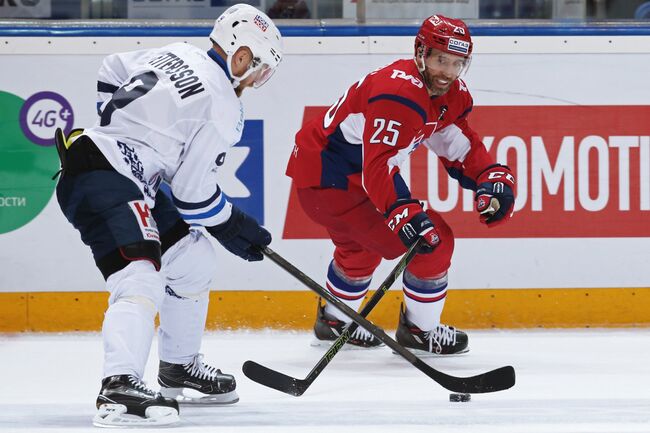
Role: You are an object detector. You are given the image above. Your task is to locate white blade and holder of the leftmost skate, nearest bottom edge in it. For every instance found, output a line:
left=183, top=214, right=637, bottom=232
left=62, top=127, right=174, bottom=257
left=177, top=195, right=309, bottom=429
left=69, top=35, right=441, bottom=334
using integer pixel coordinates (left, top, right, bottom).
left=93, top=404, right=180, bottom=428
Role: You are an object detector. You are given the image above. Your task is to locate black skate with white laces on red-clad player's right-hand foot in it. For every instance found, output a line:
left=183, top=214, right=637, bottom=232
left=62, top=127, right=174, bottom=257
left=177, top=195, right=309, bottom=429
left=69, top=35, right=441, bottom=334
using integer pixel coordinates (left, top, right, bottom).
left=395, top=306, right=469, bottom=356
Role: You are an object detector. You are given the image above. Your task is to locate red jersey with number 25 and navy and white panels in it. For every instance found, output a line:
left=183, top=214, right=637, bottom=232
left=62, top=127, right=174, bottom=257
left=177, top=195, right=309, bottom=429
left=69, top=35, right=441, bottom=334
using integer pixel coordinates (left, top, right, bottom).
left=287, top=59, right=494, bottom=213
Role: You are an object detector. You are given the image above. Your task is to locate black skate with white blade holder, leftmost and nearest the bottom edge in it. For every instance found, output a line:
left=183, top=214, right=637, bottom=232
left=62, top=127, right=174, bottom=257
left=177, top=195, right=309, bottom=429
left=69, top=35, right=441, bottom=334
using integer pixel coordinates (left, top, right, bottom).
left=93, top=374, right=179, bottom=427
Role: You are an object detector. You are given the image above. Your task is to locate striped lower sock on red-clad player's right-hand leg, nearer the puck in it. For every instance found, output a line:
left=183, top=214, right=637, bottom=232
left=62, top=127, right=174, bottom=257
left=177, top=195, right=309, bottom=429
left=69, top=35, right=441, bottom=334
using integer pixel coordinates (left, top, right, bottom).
left=402, top=270, right=447, bottom=331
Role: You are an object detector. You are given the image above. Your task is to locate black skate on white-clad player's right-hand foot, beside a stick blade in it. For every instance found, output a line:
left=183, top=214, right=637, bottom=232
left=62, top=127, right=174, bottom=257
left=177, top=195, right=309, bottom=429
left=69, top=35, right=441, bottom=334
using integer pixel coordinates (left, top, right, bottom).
left=158, top=353, right=239, bottom=405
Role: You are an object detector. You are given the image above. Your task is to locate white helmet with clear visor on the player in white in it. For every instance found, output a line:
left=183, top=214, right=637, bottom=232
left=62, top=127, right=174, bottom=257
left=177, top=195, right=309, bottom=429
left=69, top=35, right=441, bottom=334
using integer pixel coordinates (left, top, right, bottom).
left=210, top=3, right=282, bottom=88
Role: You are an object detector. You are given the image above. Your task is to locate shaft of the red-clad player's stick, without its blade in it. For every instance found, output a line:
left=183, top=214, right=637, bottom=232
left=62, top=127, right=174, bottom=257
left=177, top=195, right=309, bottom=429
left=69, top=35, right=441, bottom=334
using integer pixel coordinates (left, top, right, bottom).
left=302, top=238, right=423, bottom=386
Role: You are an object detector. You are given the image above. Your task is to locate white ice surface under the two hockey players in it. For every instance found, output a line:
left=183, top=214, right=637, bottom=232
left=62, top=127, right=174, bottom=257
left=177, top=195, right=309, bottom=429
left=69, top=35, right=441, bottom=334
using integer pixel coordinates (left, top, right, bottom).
left=0, top=329, right=650, bottom=433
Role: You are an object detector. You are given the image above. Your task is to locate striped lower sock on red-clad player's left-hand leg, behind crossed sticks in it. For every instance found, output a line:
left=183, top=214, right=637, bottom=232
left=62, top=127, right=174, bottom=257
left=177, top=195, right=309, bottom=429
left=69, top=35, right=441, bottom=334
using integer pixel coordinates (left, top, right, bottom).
left=325, top=260, right=372, bottom=323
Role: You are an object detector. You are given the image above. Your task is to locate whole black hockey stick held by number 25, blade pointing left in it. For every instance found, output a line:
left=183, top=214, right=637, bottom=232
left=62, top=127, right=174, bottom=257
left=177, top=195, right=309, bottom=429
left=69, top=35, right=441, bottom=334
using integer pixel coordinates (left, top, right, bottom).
left=242, top=240, right=422, bottom=397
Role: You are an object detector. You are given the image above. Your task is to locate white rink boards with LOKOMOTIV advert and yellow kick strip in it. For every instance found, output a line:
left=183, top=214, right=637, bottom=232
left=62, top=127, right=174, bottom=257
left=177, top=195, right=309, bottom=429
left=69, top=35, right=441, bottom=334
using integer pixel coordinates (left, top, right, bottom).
left=0, top=28, right=650, bottom=331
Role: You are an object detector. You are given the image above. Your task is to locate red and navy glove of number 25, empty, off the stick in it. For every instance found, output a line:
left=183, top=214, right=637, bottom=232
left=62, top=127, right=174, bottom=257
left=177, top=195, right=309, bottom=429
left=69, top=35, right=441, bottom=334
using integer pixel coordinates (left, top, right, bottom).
left=474, top=164, right=515, bottom=227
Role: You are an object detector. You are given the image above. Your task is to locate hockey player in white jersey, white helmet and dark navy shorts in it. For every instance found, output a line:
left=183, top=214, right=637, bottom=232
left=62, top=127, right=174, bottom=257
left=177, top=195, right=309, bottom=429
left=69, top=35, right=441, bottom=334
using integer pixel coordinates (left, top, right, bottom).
left=56, top=4, right=282, bottom=426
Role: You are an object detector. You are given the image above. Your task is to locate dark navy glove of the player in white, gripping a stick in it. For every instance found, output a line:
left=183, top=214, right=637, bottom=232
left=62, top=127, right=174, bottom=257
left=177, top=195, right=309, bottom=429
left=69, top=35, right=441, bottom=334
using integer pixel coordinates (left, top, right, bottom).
left=207, top=206, right=271, bottom=262
